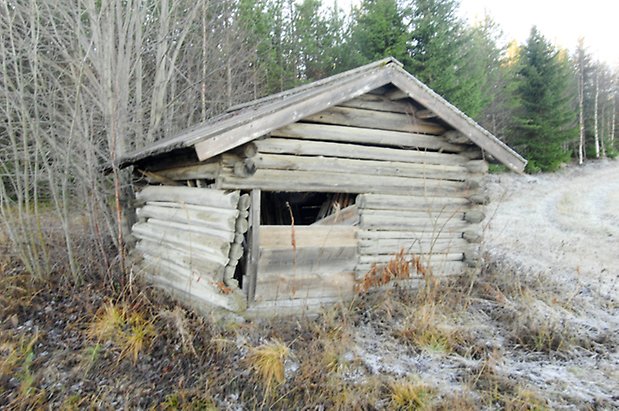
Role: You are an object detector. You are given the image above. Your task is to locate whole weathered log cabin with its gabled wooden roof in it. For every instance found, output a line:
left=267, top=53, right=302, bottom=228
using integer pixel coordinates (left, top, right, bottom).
left=117, top=58, right=526, bottom=315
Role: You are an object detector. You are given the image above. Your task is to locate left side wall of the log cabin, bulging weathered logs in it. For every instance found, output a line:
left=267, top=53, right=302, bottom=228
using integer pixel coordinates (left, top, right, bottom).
left=133, top=186, right=249, bottom=311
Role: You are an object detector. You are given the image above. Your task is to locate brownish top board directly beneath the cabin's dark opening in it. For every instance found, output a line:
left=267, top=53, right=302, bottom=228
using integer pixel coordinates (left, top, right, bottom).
left=260, top=225, right=357, bottom=249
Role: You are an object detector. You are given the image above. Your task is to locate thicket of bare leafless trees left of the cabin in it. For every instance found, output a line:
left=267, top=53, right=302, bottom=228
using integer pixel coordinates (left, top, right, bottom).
left=0, top=0, right=264, bottom=279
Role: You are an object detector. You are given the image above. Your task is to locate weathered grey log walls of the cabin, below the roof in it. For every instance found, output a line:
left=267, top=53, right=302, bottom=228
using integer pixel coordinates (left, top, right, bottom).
left=134, top=94, right=487, bottom=310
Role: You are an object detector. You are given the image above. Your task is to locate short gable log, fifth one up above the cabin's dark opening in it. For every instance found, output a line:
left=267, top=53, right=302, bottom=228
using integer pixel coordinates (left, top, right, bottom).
left=303, top=107, right=445, bottom=135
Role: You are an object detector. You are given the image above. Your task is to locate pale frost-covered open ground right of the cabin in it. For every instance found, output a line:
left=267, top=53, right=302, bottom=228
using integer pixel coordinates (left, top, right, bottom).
left=485, top=161, right=619, bottom=300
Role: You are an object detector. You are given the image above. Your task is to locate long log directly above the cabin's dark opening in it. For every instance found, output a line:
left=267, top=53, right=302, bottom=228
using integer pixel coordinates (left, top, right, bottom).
left=221, top=170, right=470, bottom=197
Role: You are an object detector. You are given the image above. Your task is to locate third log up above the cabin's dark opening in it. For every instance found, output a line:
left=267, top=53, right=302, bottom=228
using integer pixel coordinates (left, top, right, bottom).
left=256, top=137, right=469, bottom=166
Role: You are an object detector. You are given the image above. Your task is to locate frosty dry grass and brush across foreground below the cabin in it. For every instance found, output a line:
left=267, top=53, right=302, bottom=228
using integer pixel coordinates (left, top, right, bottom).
left=0, top=248, right=619, bottom=410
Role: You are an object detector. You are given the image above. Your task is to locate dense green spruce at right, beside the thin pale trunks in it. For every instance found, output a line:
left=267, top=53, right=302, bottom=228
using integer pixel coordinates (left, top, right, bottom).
left=513, top=27, right=578, bottom=172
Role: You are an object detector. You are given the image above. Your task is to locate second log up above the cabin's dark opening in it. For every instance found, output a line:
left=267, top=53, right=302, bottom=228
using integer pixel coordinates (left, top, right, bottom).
left=254, top=154, right=467, bottom=181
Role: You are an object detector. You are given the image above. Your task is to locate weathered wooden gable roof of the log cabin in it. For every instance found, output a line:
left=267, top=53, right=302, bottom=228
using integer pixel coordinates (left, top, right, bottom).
left=118, top=57, right=526, bottom=172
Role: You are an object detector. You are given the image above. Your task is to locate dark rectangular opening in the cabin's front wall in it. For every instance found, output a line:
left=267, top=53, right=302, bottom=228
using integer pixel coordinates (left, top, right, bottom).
left=260, top=191, right=356, bottom=225
